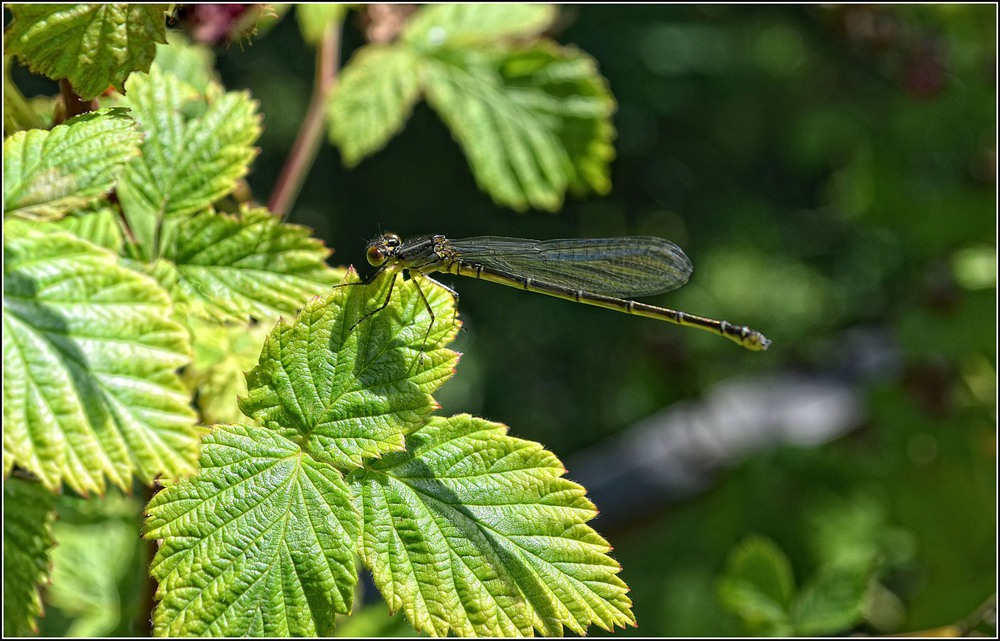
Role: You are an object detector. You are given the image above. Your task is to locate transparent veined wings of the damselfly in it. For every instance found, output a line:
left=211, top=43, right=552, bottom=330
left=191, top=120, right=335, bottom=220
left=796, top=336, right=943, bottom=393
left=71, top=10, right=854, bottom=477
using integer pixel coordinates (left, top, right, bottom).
left=450, top=236, right=693, bottom=298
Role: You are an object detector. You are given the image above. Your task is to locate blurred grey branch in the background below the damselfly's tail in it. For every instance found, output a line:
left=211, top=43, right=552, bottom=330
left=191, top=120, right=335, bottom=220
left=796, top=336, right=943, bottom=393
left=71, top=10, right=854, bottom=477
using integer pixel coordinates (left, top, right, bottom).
left=565, top=330, right=900, bottom=534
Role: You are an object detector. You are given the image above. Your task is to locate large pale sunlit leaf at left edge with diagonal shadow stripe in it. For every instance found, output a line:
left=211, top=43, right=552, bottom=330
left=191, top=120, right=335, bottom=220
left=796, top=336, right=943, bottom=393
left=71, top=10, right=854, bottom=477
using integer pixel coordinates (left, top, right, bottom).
left=3, top=225, right=198, bottom=493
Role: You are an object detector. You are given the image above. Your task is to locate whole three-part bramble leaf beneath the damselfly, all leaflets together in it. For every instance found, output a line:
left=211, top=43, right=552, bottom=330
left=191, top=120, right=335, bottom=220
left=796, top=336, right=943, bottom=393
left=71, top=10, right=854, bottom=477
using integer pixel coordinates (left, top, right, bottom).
left=146, top=271, right=634, bottom=636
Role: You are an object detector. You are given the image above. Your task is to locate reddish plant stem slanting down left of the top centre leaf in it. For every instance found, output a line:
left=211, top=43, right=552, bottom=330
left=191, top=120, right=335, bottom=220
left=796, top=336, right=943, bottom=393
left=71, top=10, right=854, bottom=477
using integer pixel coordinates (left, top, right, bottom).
left=267, top=23, right=340, bottom=217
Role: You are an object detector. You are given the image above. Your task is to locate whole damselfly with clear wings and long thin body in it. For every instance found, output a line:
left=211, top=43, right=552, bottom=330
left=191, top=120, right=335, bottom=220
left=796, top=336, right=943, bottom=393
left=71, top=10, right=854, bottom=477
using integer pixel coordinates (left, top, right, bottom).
left=358, top=234, right=771, bottom=351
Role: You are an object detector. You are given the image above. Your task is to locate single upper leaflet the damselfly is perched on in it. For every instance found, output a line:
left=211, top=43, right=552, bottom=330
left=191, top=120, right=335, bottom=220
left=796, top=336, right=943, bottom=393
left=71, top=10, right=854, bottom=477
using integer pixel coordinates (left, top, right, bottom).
left=240, top=270, right=458, bottom=468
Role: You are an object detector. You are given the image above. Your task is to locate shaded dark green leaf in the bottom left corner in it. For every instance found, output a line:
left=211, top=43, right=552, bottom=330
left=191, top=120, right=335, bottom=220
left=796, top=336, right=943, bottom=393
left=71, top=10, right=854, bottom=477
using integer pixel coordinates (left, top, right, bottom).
left=3, top=476, right=55, bottom=636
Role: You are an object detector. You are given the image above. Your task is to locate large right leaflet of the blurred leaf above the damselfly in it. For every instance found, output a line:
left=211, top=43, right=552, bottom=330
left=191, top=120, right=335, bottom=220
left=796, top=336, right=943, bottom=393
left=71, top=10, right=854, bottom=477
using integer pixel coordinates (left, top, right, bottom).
left=424, top=44, right=615, bottom=211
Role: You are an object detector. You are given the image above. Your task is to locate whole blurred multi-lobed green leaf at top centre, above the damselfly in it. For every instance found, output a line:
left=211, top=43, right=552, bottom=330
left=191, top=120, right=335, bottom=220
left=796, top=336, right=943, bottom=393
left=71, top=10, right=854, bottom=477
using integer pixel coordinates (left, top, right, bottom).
left=327, top=4, right=615, bottom=210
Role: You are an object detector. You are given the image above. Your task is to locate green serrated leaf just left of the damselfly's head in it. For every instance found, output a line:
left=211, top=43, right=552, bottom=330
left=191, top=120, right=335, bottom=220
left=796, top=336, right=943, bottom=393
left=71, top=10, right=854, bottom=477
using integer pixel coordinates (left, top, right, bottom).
left=155, top=209, right=343, bottom=322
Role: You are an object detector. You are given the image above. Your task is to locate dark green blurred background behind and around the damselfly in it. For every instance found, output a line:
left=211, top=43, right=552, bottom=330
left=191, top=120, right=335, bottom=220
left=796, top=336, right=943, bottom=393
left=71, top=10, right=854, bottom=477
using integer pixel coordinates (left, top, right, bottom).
left=13, top=5, right=997, bottom=636
